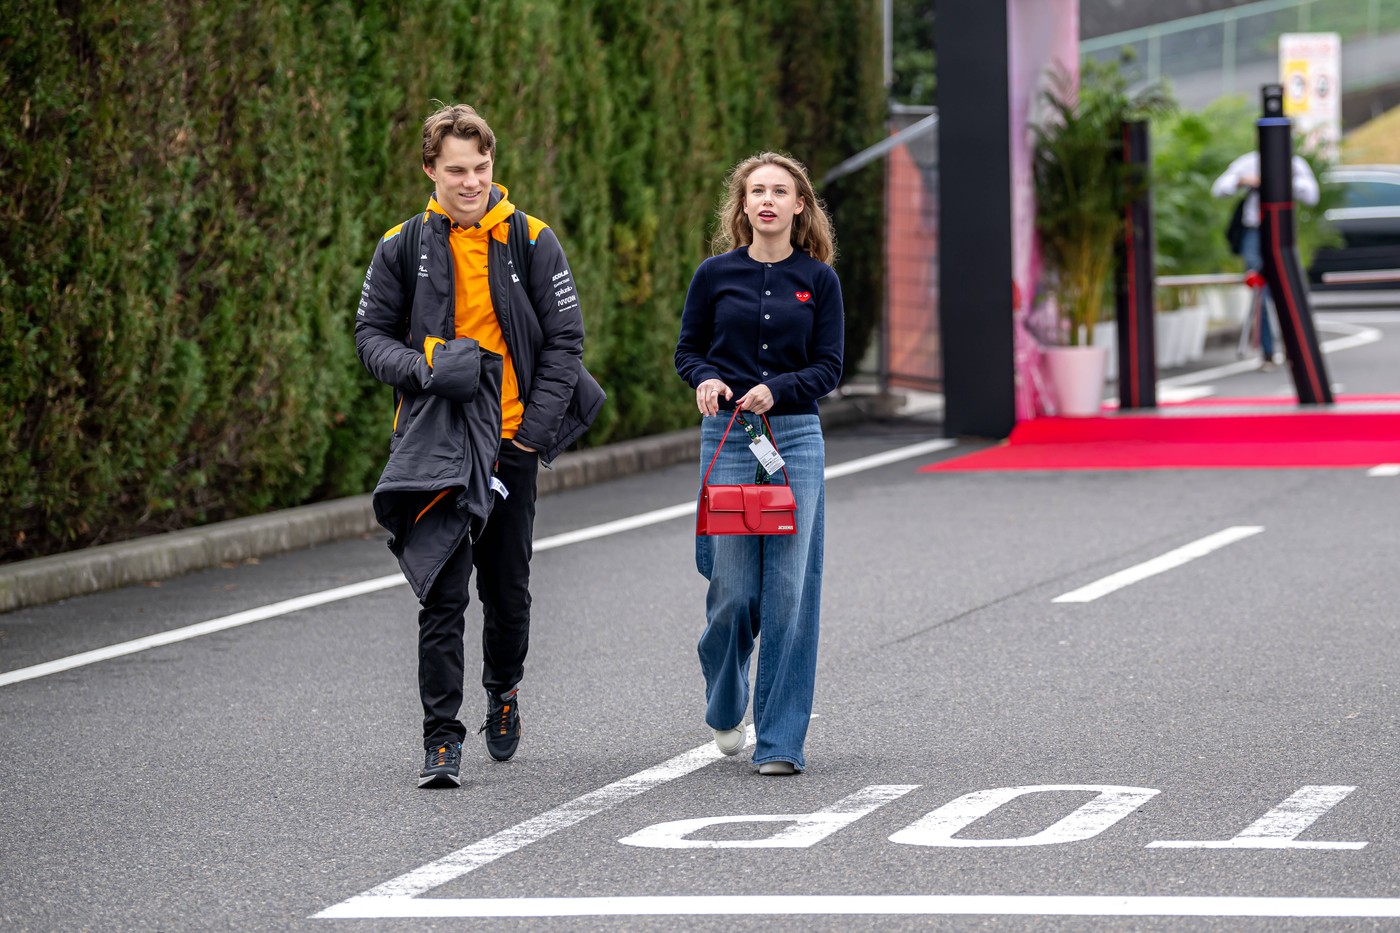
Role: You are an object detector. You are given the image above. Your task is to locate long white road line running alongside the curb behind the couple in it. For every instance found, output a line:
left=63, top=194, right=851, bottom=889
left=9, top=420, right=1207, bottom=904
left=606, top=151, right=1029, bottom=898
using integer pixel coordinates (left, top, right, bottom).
left=0, top=440, right=958, bottom=686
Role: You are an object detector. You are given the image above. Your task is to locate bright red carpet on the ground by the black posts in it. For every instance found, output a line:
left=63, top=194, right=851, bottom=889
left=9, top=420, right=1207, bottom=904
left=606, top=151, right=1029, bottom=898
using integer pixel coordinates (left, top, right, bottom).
left=921, top=396, right=1400, bottom=472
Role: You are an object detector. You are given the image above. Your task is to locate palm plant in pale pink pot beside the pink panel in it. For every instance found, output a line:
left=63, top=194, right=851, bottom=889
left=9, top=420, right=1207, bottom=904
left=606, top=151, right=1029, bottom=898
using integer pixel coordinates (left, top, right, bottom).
left=1033, top=60, right=1172, bottom=415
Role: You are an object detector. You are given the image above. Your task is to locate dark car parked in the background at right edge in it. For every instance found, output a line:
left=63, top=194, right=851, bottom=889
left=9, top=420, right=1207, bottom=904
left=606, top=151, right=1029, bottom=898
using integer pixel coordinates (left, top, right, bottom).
left=1308, top=165, right=1400, bottom=289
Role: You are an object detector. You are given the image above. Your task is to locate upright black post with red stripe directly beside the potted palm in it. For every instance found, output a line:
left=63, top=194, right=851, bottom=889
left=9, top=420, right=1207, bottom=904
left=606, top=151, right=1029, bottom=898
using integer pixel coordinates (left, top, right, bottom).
left=1114, top=120, right=1156, bottom=409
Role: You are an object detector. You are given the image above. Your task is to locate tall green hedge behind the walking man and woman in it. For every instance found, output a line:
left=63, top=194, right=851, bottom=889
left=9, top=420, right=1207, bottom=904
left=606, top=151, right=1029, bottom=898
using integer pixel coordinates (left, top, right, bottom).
left=0, top=0, right=885, bottom=560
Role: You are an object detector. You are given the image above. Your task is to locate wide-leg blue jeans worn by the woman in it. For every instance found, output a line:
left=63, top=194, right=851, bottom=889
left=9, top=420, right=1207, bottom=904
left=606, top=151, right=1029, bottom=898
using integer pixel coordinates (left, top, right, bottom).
left=696, top=412, right=826, bottom=769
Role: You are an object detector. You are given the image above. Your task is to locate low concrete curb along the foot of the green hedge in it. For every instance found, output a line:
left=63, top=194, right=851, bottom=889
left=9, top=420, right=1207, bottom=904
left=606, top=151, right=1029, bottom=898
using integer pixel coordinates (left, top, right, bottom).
left=0, top=398, right=865, bottom=612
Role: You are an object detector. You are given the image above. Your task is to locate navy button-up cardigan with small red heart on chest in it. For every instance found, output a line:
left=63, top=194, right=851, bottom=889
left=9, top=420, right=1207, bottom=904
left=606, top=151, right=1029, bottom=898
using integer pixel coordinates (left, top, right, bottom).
left=676, top=247, right=846, bottom=415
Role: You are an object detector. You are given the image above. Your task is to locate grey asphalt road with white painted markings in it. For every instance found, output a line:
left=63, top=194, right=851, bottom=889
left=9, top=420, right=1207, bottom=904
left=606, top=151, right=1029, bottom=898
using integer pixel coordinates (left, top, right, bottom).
left=0, top=311, right=1400, bottom=933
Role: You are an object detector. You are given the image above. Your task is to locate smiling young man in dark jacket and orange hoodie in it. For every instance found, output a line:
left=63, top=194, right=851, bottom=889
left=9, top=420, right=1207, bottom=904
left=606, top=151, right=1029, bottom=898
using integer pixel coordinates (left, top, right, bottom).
left=356, top=104, right=605, bottom=787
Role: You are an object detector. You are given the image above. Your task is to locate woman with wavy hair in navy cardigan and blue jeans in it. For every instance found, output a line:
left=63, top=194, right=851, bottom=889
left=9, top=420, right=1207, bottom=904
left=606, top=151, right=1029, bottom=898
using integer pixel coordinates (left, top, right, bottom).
left=675, top=153, right=846, bottom=775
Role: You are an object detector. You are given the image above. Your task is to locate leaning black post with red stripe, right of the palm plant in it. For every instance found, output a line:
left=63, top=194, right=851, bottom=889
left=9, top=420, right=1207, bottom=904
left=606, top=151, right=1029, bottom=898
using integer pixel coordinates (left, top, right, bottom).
left=1259, top=84, right=1333, bottom=405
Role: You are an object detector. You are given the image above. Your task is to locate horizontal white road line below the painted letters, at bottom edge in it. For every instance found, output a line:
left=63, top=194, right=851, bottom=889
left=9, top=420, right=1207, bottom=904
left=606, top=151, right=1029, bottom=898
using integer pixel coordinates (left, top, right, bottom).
left=316, top=894, right=1400, bottom=920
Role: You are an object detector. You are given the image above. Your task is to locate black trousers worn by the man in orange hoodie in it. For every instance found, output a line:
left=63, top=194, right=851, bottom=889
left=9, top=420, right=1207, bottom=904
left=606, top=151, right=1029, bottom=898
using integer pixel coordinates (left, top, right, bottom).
left=419, top=440, right=539, bottom=748
